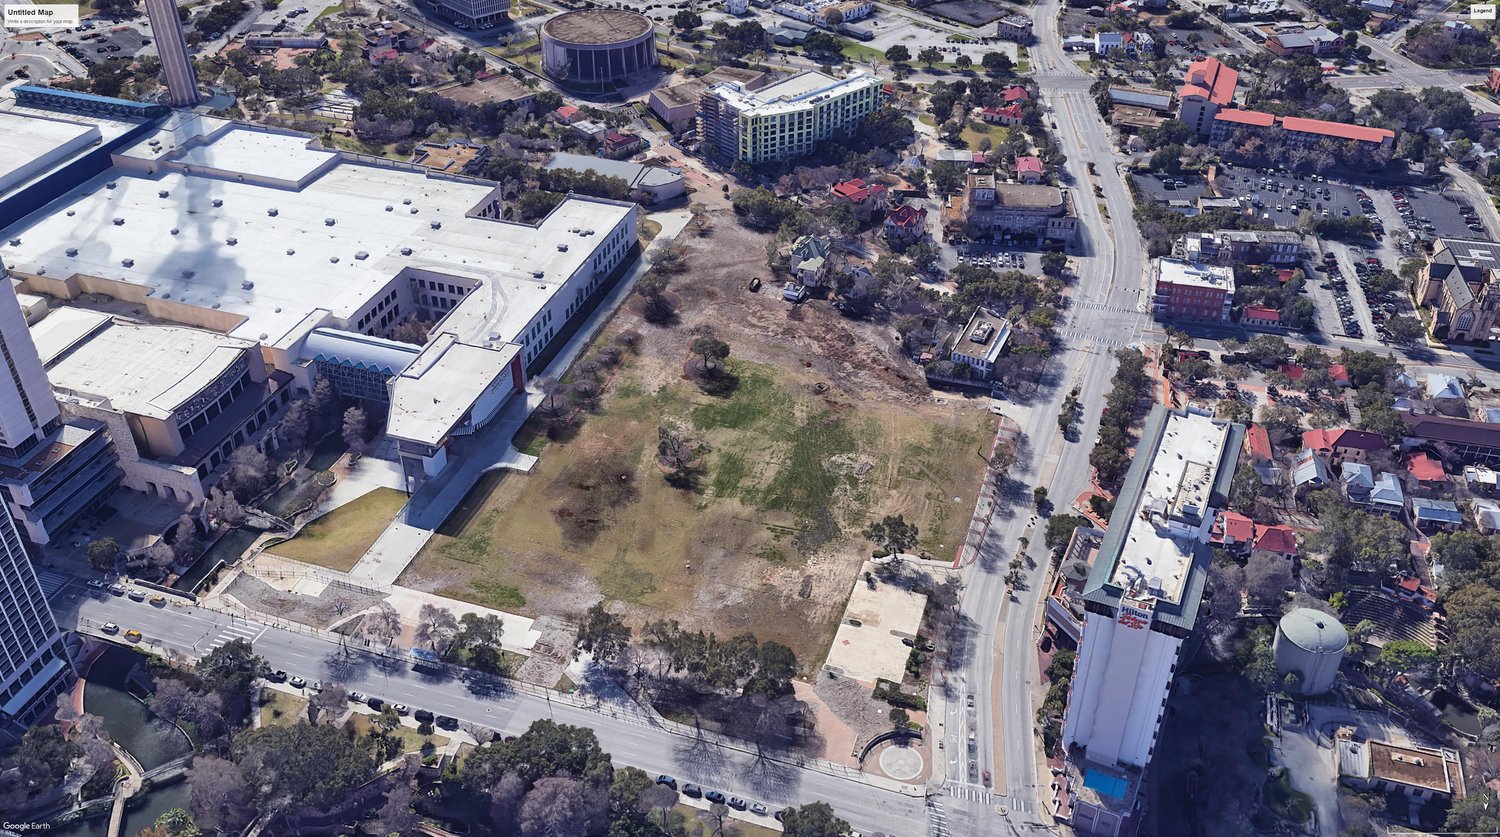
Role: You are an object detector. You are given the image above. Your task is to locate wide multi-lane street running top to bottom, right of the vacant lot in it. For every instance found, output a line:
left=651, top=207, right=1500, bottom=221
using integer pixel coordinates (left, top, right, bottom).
left=944, top=0, right=1151, bottom=834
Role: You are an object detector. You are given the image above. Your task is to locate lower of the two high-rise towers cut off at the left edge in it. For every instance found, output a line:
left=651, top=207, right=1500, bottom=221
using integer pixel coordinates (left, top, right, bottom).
left=0, top=515, right=74, bottom=741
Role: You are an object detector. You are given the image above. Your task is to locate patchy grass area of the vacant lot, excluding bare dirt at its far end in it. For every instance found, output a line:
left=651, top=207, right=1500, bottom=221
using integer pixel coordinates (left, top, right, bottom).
left=402, top=356, right=993, bottom=662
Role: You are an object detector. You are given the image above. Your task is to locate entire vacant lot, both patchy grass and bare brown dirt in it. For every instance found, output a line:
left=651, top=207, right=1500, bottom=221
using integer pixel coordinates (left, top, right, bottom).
left=399, top=213, right=995, bottom=669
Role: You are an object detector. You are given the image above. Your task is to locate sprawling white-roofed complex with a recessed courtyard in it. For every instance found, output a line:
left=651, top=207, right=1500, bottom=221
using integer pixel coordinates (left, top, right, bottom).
left=0, top=90, right=638, bottom=501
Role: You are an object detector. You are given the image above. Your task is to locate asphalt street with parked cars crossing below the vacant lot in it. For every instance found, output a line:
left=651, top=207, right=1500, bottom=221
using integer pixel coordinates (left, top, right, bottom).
left=64, top=591, right=930, bottom=837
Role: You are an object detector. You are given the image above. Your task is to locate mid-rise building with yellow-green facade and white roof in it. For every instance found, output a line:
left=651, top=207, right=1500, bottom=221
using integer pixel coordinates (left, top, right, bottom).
left=699, top=71, right=882, bottom=165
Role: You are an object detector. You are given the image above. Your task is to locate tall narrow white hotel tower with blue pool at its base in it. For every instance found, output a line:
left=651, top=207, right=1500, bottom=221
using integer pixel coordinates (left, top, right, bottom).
left=1062, top=407, right=1244, bottom=834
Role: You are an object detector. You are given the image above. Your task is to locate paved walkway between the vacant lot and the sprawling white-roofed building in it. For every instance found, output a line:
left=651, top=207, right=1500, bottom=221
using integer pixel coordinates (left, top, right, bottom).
left=350, top=210, right=690, bottom=587
